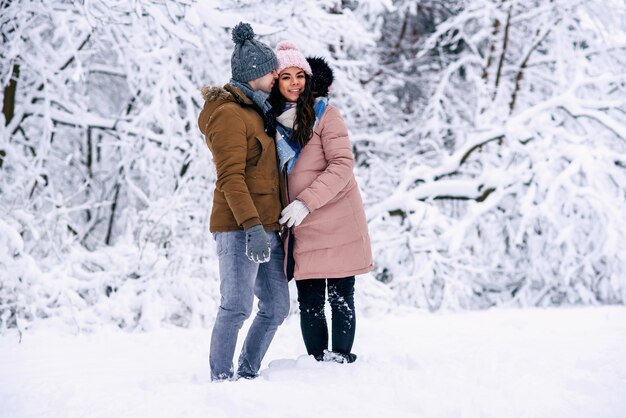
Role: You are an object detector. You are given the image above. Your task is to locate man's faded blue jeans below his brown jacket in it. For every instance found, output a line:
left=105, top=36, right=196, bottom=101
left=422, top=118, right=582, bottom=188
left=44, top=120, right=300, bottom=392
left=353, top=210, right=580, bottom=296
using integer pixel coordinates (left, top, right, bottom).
left=209, top=231, right=289, bottom=380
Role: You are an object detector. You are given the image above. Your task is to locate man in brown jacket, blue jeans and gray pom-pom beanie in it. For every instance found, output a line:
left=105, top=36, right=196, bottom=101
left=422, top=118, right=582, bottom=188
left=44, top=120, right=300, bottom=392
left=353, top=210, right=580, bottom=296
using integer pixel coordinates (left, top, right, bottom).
left=198, top=23, right=289, bottom=381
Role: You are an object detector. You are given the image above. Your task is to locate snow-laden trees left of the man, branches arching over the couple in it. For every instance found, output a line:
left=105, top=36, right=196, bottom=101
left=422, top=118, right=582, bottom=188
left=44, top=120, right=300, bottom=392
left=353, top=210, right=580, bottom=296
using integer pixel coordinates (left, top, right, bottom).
left=0, top=0, right=374, bottom=329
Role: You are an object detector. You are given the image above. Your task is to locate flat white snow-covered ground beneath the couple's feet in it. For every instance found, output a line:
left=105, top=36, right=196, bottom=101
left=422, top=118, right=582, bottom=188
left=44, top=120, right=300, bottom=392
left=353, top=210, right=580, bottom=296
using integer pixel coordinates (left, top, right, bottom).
left=0, top=307, right=626, bottom=418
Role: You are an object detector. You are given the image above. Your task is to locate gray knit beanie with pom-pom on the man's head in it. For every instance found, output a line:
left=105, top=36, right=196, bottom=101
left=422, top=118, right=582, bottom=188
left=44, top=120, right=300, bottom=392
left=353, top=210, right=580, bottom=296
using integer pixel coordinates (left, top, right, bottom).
left=230, top=22, right=278, bottom=83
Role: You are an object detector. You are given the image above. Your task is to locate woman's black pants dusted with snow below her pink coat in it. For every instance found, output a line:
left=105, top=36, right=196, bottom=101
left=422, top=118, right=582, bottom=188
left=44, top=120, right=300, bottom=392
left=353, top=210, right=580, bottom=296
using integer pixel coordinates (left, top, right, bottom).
left=296, top=276, right=356, bottom=357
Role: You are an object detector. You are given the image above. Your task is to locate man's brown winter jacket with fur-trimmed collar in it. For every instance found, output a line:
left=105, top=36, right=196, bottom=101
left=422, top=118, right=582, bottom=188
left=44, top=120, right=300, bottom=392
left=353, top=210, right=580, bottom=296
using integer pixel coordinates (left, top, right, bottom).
left=198, top=84, right=281, bottom=232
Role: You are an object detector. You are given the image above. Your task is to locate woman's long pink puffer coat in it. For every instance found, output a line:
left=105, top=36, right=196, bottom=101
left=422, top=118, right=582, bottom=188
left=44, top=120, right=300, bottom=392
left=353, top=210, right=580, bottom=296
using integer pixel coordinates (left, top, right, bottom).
left=288, top=105, right=373, bottom=280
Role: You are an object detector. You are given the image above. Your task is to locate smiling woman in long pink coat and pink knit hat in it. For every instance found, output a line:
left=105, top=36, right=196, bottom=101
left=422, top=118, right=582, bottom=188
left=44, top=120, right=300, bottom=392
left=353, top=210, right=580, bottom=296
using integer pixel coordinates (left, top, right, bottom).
left=270, top=41, right=372, bottom=363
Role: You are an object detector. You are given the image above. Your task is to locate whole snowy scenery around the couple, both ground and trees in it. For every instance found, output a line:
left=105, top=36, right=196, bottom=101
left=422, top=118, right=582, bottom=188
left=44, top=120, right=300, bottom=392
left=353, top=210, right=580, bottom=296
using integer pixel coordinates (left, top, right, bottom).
left=0, top=0, right=626, bottom=418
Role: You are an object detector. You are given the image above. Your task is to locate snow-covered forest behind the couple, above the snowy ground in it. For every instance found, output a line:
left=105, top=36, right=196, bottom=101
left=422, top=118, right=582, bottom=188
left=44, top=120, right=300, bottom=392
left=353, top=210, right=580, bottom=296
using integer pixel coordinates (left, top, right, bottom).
left=0, top=0, right=626, bottom=332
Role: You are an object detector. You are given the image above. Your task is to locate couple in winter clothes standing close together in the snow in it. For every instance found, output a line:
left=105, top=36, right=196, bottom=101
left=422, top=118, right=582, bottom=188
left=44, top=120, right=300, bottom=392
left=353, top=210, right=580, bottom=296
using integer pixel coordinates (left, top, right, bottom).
left=198, top=23, right=372, bottom=381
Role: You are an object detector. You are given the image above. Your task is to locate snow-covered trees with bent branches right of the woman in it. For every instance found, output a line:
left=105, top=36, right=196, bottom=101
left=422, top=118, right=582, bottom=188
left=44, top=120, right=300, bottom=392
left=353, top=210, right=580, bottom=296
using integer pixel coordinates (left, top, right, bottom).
left=363, top=0, right=626, bottom=309
